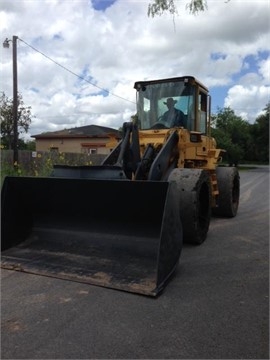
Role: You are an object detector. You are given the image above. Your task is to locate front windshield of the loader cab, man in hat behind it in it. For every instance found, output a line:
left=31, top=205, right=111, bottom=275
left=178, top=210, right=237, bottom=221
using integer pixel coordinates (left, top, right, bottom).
left=137, top=81, right=194, bottom=130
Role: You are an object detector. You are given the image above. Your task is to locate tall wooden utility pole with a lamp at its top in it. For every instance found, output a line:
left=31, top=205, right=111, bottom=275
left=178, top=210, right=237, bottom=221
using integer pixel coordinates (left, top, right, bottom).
left=3, top=36, right=19, bottom=168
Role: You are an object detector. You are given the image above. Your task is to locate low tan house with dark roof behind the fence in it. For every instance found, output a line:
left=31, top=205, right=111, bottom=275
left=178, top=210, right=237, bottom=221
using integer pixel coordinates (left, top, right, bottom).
left=32, top=125, right=121, bottom=155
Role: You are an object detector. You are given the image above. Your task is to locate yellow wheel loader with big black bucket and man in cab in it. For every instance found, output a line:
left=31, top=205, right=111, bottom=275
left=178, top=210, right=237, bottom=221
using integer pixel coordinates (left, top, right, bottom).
left=1, top=76, right=240, bottom=296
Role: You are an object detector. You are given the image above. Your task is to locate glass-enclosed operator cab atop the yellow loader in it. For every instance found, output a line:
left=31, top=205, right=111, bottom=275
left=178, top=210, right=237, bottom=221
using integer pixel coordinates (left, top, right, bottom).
left=134, top=76, right=210, bottom=134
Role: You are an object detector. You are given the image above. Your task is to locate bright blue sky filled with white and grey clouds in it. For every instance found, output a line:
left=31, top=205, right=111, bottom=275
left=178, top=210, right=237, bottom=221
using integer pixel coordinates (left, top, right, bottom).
left=0, top=0, right=270, bottom=139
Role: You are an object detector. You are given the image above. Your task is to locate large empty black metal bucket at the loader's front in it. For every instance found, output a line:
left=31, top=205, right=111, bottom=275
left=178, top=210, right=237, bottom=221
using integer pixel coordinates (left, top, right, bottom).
left=1, top=177, right=182, bottom=296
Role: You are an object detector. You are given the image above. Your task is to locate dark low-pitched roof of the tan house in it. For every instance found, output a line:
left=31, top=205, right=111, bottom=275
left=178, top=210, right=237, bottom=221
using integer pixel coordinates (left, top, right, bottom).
left=32, top=125, right=121, bottom=139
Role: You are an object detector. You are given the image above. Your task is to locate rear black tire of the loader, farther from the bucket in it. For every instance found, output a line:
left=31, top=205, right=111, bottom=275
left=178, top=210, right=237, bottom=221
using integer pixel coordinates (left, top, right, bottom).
left=212, top=166, right=240, bottom=217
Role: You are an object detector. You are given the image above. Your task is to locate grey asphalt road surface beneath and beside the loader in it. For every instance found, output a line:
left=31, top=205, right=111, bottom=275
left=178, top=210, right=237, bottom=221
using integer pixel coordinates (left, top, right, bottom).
left=1, top=167, right=269, bottom=359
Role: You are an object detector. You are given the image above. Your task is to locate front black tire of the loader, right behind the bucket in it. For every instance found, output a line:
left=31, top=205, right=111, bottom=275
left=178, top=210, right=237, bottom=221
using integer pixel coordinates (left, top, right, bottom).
left=169, top=169, right=211, bottom=245
